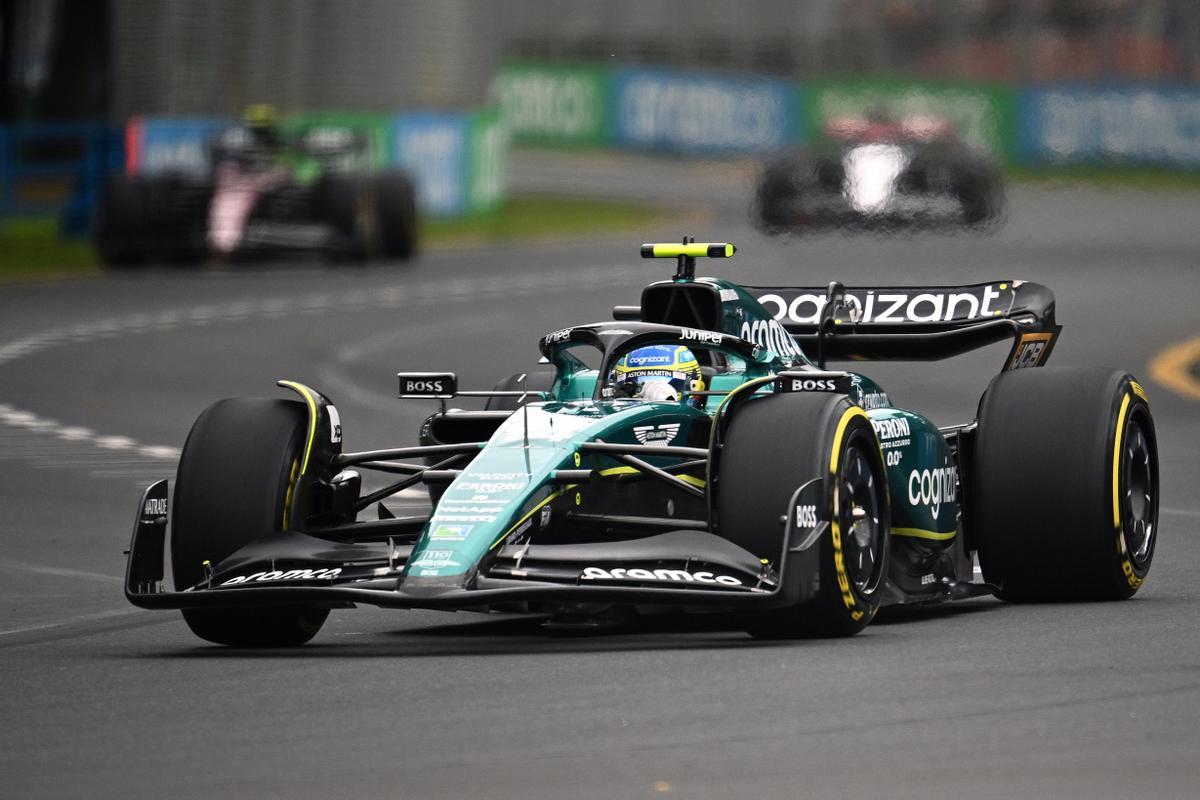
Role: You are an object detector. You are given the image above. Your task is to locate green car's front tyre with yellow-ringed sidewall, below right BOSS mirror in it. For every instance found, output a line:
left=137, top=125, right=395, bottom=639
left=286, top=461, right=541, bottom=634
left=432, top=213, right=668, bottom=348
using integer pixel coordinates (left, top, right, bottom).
left=716, top=393, right=889, bottom=638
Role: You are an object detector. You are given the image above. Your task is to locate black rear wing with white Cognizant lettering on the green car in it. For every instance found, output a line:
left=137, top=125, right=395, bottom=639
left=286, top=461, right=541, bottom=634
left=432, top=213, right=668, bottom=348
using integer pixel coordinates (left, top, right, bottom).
left=744, top=281, right=1062, bottom=369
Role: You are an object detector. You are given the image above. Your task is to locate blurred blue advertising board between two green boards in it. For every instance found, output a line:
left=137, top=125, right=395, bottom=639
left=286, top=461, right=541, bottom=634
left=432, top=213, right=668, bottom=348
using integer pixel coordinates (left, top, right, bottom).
left=608, top=70, right=803, bottom=154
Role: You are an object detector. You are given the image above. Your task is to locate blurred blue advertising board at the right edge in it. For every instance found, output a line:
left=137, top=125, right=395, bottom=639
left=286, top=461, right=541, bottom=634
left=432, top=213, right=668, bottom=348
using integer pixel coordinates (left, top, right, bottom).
left=1019, top=86, right=1200, bottom=169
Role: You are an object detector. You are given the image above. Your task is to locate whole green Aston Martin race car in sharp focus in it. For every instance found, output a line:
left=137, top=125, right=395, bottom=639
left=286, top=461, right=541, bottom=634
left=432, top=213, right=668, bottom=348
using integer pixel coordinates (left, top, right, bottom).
left=125, top=241, right=1159, bottom=645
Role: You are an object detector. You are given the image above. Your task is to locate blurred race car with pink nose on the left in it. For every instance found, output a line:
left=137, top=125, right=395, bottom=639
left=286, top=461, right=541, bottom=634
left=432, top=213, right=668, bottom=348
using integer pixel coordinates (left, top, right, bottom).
left=96, top=107, right=418, bottom=266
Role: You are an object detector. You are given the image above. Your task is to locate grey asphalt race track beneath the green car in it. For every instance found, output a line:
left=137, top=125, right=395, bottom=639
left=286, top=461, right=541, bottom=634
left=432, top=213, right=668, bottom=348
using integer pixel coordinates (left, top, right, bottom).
left=0, top=156, right=1200, bottom=799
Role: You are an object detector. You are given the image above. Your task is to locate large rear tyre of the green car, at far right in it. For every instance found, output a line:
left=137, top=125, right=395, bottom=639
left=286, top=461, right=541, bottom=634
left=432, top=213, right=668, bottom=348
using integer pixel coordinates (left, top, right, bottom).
left=970, top=367, right=1159, bottom=602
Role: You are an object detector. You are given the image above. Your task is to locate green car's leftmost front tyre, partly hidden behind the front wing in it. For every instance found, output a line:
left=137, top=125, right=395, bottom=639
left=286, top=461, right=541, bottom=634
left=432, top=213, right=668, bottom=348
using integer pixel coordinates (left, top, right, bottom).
left=170, top=398, right=329, bottom=646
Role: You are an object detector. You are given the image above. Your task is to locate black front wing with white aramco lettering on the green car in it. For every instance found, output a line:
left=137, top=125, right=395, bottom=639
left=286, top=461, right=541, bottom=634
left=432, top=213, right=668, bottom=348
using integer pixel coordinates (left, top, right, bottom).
left=125, top=479, right=829, bottom=609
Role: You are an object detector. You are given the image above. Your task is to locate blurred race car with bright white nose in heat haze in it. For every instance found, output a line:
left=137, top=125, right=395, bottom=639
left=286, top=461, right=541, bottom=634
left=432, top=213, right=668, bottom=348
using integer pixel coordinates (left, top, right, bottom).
left=752, top=114, right=1004, bottom=233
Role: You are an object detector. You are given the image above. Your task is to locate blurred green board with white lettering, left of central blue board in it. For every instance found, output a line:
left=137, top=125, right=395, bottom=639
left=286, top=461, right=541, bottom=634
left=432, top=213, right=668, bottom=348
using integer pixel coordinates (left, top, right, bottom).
left=491, top=61, right=610, bottom=146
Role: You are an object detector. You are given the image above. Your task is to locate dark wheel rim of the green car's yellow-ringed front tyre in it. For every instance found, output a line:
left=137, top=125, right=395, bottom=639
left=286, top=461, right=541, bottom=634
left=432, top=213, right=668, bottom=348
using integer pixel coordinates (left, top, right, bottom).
left=838, top=444, right=883, bottom=594
